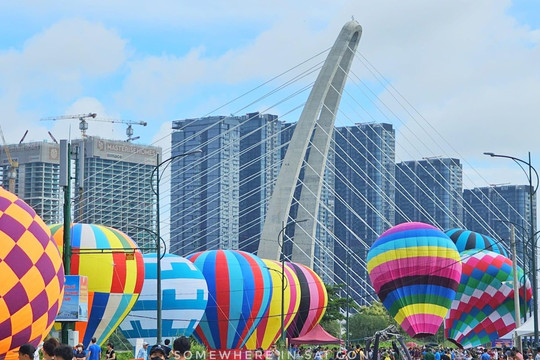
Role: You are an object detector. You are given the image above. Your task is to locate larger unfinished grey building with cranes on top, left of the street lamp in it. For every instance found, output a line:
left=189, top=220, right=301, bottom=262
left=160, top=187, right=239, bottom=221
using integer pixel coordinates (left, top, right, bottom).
left=72, top=136, right=161, bottom=252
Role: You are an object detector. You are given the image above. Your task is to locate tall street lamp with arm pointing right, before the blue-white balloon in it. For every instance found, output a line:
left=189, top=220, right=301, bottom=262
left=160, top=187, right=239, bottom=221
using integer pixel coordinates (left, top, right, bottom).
left=150, top=150, right=202, bottom=344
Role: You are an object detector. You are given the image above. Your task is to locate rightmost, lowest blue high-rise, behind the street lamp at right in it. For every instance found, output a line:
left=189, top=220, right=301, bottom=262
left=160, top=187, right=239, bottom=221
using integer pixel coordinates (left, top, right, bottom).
left=463, top=185, right=536, bottom=259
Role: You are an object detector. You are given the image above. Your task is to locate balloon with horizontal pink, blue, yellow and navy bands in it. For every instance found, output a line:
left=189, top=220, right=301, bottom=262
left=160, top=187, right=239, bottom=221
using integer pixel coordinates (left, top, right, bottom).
left=367, top=222, right=461, bottom=338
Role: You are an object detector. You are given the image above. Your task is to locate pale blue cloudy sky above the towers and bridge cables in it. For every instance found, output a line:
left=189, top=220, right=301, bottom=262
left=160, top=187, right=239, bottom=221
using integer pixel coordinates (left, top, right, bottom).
left=0, top=0, right=540, bottom=187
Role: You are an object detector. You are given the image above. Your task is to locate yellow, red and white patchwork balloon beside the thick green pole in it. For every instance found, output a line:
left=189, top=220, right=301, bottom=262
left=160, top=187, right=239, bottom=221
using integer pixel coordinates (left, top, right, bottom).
left=51, top=224, right=144, bottom=347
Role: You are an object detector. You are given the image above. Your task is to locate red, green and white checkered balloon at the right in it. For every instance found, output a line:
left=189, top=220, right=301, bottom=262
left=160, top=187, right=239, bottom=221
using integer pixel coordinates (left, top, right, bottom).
left=445, top=250, right=532, bottom=348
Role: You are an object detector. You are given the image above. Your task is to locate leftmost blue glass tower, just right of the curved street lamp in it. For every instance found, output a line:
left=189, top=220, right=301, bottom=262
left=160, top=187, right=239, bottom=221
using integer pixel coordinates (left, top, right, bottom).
left=170, top=116, right=240, bottom=255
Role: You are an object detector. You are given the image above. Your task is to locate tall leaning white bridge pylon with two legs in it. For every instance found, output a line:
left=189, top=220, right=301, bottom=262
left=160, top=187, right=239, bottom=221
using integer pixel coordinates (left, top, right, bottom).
left=257, top=20, right=362, bottom=268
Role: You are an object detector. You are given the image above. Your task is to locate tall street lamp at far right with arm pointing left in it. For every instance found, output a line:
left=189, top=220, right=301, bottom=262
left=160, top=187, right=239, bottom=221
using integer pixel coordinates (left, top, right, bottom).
left=484, top=152, right=540, bottom=346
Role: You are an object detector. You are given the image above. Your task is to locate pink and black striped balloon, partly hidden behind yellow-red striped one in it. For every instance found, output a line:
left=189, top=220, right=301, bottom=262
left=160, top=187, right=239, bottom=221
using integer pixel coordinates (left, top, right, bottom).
left=287, top=263, right=328, bottom=338
